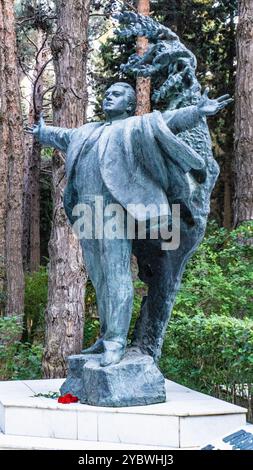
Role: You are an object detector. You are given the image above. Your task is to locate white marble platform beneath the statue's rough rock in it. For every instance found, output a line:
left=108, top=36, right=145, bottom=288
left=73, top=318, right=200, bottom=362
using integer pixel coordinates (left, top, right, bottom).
left=0, top=379, right=246, bottom=449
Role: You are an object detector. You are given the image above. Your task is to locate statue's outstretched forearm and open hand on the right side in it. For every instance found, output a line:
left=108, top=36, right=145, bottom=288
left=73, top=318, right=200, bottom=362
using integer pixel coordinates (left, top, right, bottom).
left=163, top=88, right=233, bottom=134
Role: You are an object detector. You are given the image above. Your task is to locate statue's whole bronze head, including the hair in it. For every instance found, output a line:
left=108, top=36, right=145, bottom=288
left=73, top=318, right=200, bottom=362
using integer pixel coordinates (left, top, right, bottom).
left=103, top=82, right=136, bottom=119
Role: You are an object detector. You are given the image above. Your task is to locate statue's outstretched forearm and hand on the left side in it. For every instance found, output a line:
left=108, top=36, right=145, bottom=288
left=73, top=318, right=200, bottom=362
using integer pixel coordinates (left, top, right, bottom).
left=28, top=114, right=74, bottom=152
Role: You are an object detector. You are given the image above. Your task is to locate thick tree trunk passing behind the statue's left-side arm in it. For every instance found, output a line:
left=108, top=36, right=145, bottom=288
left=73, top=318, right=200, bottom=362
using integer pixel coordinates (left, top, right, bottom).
left=43, top=0, right=90, bottom=377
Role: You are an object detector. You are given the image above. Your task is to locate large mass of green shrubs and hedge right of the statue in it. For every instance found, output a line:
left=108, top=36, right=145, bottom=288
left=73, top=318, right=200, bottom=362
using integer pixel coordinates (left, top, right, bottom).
left=160, top=222, right=253, bottom=420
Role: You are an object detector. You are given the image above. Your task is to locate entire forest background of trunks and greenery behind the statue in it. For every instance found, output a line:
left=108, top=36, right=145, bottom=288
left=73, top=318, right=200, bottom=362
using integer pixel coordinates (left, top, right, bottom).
left=0, top=0, right=253, bottom=420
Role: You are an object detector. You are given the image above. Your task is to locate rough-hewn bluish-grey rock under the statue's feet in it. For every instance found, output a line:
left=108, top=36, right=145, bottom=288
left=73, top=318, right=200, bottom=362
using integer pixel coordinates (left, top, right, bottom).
left=61, top=351, right=166, bottom=407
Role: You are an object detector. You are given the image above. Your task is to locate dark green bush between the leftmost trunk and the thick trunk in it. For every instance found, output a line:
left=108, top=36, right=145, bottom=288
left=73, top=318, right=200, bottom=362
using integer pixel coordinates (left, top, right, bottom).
left=23, top=267, right=48, bottom=342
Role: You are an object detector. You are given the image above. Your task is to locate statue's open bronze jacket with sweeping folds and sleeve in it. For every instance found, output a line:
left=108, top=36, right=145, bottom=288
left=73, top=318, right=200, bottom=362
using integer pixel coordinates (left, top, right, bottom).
left=40, top=107, right=205, bottom=231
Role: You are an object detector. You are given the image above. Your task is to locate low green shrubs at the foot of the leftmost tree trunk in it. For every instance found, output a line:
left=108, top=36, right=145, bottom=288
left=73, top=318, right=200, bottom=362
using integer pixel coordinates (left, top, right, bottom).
left=0, top=317, right=43, bottom=380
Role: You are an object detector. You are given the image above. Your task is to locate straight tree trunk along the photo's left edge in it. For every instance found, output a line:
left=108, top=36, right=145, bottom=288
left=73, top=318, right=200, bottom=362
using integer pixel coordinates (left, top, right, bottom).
left=0, top=0, right=24, bottom=316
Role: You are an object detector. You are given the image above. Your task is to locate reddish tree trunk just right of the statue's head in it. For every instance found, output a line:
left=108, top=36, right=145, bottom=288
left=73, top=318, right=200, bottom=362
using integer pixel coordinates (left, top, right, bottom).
left=136, top=0, right=151, bottom=116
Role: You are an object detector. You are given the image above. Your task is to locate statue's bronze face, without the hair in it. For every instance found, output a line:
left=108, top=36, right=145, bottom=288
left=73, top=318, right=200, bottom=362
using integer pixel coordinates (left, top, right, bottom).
left=103, top=84, right=129, bottom=117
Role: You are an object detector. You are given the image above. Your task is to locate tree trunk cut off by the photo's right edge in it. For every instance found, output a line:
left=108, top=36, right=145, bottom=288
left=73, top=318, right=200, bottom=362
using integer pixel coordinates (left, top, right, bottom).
left=234, top=0, right=253, bottom=225
